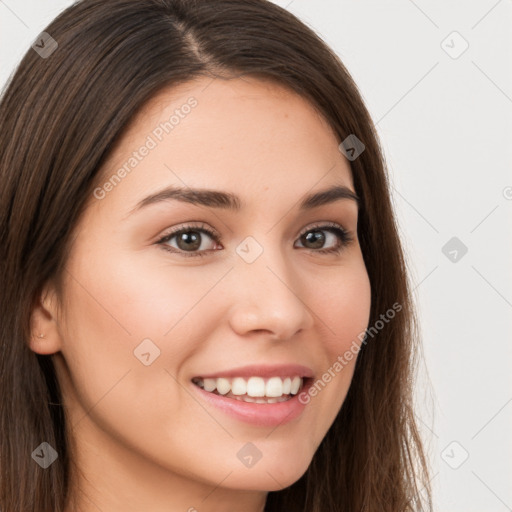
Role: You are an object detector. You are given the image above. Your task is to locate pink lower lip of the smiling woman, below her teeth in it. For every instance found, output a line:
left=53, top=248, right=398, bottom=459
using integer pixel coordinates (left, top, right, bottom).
left=192, top=379, right=312, bottom=427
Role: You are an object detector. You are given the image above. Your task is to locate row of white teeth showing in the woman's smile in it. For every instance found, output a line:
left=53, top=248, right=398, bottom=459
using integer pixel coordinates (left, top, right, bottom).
left=194, top=376, right=303, bottom=403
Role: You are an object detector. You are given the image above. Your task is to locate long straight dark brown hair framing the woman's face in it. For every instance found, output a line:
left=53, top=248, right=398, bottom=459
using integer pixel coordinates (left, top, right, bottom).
left=0, top=0, right=432, bottom=512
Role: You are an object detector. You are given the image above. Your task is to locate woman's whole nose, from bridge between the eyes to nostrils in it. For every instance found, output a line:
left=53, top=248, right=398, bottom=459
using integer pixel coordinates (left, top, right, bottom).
left=227, top=236, right=313, bottom=339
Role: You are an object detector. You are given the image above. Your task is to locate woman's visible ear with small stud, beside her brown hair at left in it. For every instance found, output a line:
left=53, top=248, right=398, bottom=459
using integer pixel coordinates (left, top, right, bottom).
left=29, top=284, right=62, bottom=355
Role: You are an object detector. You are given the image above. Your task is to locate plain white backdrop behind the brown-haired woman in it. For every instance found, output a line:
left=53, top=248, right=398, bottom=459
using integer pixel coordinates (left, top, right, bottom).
left=0, top=0, right=512, bottom=512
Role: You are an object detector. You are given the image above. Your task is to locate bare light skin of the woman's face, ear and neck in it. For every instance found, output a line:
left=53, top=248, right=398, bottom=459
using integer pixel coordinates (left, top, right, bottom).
left=30, top=77, right=370, bottom=512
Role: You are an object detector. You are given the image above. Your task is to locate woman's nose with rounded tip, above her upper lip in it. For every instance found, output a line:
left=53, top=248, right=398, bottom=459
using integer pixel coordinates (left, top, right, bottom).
left=229, top=245, right=314, bottom=341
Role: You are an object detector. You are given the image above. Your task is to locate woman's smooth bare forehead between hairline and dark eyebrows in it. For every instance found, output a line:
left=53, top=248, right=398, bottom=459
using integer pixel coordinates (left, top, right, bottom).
left=93, top=77, right=353, bottom=214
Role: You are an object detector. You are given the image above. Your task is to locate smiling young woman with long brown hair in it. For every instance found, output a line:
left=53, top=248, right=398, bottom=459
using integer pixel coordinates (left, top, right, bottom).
left=0, top=0, right=431, bottom=512
